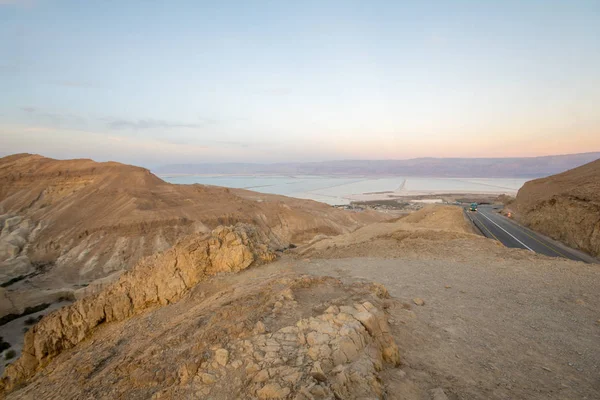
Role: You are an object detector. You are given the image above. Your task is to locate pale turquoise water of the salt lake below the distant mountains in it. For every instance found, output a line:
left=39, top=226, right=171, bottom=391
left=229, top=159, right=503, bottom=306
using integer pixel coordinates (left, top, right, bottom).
left=161, top=175, right=527, bottom=204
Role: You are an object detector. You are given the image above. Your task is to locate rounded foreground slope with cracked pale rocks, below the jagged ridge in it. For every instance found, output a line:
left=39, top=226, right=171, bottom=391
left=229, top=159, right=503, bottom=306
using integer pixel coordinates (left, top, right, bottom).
left=2, top=272, right=400, bottom=400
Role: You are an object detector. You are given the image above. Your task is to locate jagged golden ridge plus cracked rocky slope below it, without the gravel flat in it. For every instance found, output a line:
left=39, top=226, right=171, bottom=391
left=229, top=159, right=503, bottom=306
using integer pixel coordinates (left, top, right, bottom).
left=0, top=225, right=400, bottom=399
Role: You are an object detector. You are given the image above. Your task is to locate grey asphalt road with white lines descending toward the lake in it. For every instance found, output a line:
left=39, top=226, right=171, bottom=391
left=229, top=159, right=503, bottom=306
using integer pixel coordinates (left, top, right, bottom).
left=466, top=206, right=591, bottom=262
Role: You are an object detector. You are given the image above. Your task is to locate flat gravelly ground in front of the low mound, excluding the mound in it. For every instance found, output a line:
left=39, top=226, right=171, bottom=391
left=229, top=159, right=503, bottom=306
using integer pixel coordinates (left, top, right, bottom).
left=284, top=254, right=600, bottom=399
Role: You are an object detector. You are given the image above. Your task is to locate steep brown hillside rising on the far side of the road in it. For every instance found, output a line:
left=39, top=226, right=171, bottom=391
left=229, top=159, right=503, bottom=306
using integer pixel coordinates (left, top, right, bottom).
left=510, top=160, right=600, bottom=256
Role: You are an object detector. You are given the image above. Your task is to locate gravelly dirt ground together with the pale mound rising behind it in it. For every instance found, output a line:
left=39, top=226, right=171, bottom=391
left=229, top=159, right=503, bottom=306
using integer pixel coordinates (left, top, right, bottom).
left=269, top=206, right=600, bottom=399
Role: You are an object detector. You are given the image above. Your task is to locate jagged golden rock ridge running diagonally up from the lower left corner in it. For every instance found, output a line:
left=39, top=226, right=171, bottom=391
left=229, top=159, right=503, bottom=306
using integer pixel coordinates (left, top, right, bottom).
left=2, top=224, right=275, bottom=389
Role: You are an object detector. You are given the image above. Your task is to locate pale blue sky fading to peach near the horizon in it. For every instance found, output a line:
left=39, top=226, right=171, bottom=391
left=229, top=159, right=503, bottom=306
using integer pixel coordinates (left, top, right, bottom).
left=0, top=0, right=600, bottom=167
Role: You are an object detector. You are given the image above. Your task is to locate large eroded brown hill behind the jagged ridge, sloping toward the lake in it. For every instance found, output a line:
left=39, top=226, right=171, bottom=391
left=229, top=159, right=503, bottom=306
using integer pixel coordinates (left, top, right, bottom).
left=0, top=154, right=382, bottom=313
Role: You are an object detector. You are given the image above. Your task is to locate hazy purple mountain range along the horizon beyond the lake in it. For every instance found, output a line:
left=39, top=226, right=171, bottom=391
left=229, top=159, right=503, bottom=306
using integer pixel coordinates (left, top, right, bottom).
left=153, top=152, right=600, bottom=178
